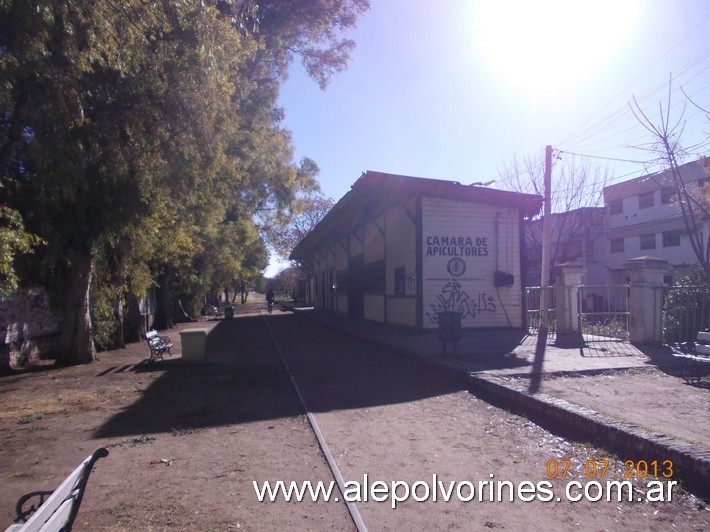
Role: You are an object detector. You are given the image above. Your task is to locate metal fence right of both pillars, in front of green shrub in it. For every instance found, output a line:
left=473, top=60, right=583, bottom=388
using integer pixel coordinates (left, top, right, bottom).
left=662, top=286, right=710, bottom=344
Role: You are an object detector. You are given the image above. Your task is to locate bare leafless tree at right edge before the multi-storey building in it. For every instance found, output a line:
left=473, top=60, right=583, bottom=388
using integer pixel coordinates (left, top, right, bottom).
left=631, top=82, right=710, bottom=280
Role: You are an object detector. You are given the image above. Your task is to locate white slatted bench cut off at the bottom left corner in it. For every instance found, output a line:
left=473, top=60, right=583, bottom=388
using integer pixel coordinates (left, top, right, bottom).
left=5, top=447, right=108, bottom=532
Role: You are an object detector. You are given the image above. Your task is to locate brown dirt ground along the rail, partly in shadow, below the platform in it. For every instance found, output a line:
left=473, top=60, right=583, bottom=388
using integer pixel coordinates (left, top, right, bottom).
left=0, top=307, right=710, bottom=530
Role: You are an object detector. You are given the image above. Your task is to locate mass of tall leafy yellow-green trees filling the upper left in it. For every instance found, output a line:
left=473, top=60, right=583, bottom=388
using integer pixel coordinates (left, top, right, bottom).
left=0, top=0, right=369, bottom=364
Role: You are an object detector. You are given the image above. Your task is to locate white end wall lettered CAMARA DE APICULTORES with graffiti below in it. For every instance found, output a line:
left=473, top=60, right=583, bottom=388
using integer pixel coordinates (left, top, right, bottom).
left=422, top=198, right=522, bottom=328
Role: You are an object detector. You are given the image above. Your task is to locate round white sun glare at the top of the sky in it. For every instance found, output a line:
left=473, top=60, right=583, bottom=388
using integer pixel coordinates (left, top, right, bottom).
left=473, top=0, right=641, bottom=94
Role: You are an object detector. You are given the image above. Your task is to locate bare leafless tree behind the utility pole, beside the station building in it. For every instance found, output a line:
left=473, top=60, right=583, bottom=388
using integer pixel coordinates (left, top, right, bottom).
left=499, top=154, right=612, bottom=282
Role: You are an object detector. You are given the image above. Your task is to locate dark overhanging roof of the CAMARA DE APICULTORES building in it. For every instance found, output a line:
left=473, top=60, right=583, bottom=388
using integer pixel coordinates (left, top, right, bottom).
left=290, top=171, right=542, bottom=260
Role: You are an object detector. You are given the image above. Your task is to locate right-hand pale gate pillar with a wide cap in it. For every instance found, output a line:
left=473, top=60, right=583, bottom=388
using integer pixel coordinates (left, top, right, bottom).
left=624, top=256, right=672, bottom=344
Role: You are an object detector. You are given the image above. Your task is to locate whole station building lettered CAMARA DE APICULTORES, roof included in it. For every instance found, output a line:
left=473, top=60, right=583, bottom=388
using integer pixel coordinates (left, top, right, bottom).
left=290, top=171, right=542, bottom=330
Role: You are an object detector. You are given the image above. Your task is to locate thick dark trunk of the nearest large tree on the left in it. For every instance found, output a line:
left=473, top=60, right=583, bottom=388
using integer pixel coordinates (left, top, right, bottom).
left=57, top=252, right=96, bottom=365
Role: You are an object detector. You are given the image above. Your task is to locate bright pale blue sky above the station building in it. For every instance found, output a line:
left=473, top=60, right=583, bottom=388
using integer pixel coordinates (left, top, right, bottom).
left=267, top=0, right=710, bottom=273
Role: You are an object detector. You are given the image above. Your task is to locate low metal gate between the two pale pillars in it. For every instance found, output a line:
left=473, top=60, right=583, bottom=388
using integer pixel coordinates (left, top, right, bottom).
left=577, top=284, right=630, bottom=340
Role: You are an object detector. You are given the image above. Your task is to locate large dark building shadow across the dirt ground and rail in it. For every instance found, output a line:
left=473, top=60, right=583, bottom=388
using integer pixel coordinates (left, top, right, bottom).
left=93, top=314, right=462, bottom=438
